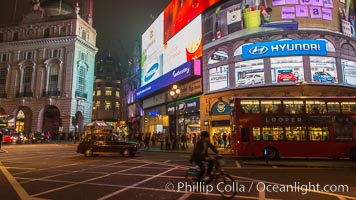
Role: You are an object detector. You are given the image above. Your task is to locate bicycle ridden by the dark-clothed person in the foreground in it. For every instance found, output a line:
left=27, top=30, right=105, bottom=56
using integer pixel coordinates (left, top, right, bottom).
left=185, top=156, right=237, bottom=199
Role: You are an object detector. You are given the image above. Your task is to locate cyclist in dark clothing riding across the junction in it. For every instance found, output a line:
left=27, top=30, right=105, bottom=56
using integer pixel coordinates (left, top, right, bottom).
left=190, top=131, right=219, bottom=182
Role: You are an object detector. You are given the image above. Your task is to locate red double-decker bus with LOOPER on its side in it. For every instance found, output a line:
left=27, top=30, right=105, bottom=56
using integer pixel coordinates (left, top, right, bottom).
left=233, top=97, right=356, bottom=160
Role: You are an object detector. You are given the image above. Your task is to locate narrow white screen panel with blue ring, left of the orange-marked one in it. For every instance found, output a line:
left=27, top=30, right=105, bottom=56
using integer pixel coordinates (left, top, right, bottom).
left=141, top=13, right=163, bottom=85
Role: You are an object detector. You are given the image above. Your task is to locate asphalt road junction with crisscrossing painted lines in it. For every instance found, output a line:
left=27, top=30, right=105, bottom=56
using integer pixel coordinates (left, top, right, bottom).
left=0, top=144, right=356, bottom=200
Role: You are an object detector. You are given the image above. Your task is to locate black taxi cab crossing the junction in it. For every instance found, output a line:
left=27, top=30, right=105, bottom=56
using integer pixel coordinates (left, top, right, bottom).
left=77, top=133, right=139, bottom=157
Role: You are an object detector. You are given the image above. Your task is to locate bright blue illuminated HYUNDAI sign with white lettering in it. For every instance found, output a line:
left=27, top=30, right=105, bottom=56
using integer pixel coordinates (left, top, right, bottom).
left=242, top=40, right=327, bottom=60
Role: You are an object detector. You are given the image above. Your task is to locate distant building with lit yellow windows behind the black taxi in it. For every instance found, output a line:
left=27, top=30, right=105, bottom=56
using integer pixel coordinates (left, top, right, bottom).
left=93, top=53, right=121, bottom=130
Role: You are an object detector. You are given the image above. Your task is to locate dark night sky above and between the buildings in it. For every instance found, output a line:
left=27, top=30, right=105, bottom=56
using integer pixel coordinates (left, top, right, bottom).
left=0, top=0, right=171, bottom=65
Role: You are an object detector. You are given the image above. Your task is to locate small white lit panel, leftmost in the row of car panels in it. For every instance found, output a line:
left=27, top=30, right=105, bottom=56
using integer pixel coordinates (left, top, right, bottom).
left=209, top=65, right=229, bottom=91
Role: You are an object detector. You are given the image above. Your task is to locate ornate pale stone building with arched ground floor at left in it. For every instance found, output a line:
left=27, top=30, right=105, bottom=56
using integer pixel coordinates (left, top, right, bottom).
left=0, top=1, right=97, bottom=136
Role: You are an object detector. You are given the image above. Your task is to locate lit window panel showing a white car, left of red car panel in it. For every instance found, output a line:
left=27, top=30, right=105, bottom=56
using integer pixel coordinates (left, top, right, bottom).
left=235, top=59, right=265, bottom=87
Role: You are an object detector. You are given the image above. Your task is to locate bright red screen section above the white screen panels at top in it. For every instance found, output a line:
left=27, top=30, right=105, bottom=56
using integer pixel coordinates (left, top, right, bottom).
left=164, top=0, right=220, bottom=42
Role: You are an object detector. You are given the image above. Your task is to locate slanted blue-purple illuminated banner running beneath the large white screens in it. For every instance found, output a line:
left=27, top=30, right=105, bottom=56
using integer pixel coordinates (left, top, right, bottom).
left=136, top=61, right=194, bottom=99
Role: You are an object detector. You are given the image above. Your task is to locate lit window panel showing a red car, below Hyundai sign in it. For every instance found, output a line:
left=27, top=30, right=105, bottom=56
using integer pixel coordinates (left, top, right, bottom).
left=271, top=56, right=304, bottom=84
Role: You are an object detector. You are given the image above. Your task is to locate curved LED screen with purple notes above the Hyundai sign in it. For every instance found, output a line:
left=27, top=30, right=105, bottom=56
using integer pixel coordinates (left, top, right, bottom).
left=202, top=0, right=356, bottom=47
